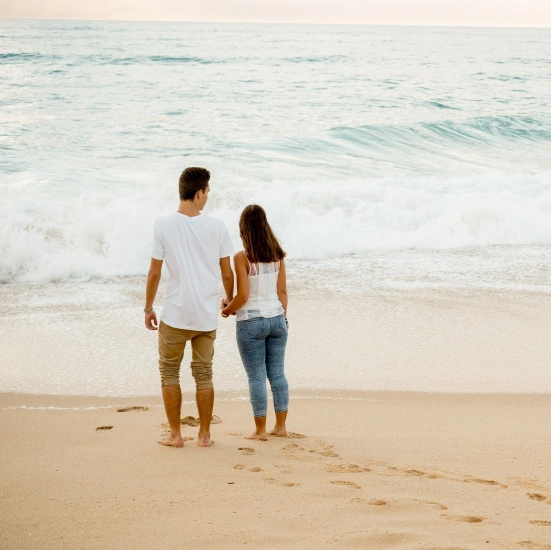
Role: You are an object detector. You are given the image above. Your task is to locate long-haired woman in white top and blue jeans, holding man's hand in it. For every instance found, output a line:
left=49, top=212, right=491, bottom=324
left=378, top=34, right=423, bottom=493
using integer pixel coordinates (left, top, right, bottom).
left=222, top=204, right=289, bottom=441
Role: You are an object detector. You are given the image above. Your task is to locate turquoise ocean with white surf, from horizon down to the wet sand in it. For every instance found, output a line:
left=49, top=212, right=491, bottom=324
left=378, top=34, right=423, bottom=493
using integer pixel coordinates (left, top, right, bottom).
left=0, top=20, right=551, bottom=391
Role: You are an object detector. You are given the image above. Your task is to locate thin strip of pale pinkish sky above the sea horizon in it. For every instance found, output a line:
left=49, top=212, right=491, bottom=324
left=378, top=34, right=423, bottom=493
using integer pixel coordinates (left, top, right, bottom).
left=0, top=0, right=551, bottom=27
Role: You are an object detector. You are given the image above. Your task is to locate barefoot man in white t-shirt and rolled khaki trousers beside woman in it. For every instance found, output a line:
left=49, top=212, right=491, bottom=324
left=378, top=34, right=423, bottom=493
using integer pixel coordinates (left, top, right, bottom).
left=144, top=168, right=234, bottom=447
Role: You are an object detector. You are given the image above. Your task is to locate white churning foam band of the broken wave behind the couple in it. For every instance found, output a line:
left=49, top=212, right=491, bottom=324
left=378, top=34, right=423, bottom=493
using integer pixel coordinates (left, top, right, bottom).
left=0, top=174, right=551, bottom=283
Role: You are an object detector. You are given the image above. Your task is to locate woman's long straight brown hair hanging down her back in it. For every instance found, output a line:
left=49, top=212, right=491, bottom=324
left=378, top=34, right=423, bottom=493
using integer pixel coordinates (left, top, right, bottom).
left=239, top=204, right=286, bottom=263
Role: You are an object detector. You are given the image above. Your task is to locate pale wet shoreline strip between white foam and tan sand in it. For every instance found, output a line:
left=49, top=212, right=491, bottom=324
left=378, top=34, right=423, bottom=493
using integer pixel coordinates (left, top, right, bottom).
left=0, top=286, right=551, bottom=396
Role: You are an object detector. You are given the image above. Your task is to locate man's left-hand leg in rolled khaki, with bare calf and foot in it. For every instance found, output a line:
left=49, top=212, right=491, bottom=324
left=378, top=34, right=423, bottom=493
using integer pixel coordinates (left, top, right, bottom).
left=159, top=322, right=188, bottom=447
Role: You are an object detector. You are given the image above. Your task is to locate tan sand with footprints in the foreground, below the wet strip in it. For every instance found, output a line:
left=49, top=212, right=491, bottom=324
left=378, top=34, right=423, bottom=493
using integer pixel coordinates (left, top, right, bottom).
left=0, top=392, right=551, bottom=550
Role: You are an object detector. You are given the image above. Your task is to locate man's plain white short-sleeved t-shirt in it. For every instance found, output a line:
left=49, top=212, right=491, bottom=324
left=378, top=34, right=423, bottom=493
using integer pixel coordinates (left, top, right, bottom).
left=151, top=212, right=233, bottom=331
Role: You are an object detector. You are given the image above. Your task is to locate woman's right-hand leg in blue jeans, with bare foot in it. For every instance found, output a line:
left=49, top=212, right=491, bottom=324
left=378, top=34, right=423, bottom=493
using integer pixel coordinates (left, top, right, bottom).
left=266, top=315, right=289, bottom=437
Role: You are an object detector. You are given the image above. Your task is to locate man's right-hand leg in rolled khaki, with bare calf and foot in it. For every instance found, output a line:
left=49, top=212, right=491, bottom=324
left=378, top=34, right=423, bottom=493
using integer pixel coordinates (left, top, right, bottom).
left=191, top=330, right=216, bottom=447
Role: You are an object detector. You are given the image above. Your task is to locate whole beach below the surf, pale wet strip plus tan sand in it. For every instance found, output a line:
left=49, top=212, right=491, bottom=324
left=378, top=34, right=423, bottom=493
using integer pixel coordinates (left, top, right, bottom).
left=0, top=288, right=551, bottom=549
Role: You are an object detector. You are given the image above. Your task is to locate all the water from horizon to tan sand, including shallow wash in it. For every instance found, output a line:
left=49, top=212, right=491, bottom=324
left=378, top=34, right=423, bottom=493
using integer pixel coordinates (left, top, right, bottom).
left=0, top=20, right=551, bottom=395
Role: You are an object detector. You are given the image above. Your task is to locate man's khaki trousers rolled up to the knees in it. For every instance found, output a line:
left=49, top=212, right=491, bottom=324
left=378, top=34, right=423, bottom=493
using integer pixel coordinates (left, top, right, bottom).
left=159, top=321, right=216, bottom=390
